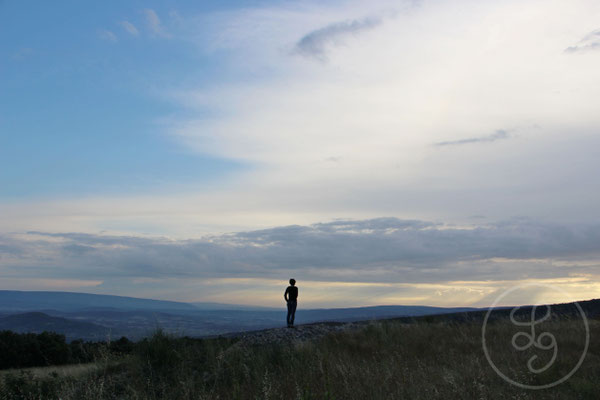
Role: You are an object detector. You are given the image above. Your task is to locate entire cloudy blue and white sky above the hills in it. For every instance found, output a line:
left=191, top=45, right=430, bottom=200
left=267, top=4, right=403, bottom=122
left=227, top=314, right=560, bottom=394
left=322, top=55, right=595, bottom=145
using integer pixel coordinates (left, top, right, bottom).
left=0, top=0, right=600, bottom=307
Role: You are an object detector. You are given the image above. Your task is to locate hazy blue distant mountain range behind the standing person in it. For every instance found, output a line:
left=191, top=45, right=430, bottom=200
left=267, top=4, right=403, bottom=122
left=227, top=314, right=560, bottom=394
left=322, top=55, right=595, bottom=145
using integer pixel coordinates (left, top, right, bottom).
left=0, top=290, right=476, bottom=340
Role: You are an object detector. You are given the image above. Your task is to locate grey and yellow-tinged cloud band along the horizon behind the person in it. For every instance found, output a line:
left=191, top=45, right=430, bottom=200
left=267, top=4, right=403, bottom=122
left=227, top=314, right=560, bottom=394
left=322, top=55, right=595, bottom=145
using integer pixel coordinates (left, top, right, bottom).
left=0, top=218, right=600, bottom=307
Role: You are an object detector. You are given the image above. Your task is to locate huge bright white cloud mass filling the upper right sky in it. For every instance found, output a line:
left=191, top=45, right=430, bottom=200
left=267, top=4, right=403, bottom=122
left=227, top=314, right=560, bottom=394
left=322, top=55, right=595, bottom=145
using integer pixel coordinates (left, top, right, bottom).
left=5, top=0, right=600, bottom=260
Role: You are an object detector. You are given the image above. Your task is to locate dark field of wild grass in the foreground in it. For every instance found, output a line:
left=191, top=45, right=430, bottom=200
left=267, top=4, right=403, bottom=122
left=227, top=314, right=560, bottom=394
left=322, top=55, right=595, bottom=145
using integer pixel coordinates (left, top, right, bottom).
left=0, top=320, right=600, bottom=400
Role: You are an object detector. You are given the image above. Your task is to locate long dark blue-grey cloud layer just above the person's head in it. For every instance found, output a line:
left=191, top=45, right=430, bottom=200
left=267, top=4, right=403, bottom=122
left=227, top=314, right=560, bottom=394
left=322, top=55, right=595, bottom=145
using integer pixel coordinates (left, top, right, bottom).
left=0, top=218, right=600, bottom=282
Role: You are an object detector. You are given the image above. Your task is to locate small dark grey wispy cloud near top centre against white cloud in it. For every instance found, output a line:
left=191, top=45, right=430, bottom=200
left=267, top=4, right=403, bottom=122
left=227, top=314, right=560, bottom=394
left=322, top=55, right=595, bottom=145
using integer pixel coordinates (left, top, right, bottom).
left=295, top=17, right=381, bottom=60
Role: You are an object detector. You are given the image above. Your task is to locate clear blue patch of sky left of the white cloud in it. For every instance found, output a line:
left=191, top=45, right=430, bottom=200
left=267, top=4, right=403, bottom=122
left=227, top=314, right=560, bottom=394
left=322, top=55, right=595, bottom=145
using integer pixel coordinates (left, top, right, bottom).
left=0, top=2, right=252, bottom=199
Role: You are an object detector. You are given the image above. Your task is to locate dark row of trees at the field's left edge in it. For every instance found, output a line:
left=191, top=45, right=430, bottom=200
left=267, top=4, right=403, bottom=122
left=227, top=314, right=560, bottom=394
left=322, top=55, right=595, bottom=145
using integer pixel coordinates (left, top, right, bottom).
left=0, top=331, right=134, bottom=369
